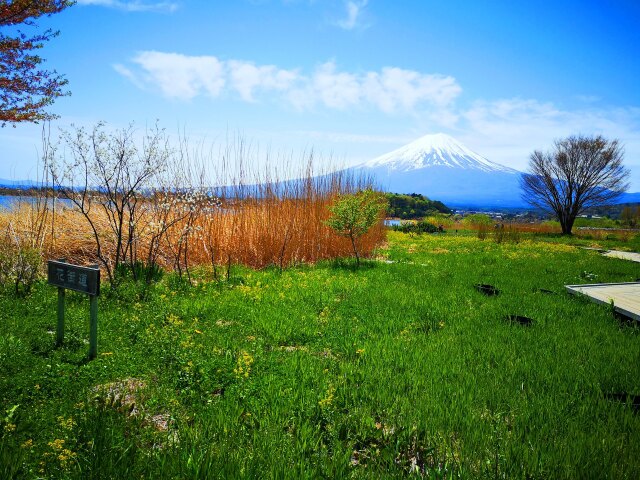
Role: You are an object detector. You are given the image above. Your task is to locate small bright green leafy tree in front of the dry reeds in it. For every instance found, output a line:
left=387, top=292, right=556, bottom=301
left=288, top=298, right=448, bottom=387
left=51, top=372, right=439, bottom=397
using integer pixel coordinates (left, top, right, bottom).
left=326, top=190, right=387, bottom=267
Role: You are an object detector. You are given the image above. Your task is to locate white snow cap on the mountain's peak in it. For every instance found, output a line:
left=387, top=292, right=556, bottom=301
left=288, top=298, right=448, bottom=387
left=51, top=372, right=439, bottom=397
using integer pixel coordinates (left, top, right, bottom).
left=362, top=133, right=518, bottom=173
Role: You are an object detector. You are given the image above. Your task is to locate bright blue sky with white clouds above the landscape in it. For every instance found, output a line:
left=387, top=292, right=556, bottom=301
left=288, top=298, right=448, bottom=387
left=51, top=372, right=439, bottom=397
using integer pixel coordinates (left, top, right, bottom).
left=0, top=0, right=640, bottom=191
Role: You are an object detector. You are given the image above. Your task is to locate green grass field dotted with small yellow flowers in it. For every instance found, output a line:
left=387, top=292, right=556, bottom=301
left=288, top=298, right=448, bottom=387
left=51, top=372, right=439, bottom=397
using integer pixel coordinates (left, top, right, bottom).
left=0, top=233, right=640, bottom=479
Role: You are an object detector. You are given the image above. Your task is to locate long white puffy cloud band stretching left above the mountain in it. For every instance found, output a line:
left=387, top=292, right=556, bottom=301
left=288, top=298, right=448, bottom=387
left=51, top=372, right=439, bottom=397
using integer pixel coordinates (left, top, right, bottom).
left=114, top=51, right=462, bottom=113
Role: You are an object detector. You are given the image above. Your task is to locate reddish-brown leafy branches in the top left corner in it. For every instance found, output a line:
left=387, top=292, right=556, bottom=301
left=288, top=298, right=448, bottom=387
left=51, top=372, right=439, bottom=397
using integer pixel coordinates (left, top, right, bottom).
left=0, top=0, right=74, bottom=126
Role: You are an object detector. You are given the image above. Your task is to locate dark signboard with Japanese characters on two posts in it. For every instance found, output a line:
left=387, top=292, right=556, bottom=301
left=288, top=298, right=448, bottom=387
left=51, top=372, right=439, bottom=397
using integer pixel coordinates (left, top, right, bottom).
left=47, top=258, right=100, bottom=359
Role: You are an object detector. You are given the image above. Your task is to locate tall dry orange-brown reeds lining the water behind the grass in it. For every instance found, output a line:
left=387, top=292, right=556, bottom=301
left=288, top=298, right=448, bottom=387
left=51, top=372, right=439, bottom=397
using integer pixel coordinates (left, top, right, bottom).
left=0, top=148, right=385, bottom=282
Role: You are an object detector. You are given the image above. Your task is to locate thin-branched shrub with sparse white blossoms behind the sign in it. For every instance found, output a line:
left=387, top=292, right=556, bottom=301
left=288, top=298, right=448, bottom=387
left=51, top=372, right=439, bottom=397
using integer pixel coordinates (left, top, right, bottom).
left=47, top=123, right=170, bottom=285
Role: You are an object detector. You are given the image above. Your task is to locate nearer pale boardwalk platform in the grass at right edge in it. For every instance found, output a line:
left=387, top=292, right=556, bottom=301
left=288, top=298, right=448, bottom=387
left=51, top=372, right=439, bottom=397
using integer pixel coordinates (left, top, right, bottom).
left=565, top=282, right=640, bottom=321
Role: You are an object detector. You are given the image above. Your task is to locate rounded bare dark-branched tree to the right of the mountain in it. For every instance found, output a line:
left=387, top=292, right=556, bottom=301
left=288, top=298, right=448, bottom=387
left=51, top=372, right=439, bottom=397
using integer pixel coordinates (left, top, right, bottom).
left=520, top=135, right=629, bottom=235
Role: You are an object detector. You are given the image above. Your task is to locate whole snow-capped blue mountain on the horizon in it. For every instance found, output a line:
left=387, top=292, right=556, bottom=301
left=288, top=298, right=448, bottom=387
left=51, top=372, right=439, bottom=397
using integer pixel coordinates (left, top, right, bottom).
left=353, top=133, right=526, bottom=207
